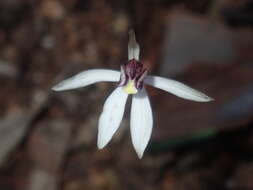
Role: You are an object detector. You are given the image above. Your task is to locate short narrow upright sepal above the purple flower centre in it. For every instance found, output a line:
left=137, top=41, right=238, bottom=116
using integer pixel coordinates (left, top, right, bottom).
left=128, top=30, right=140, bottom=60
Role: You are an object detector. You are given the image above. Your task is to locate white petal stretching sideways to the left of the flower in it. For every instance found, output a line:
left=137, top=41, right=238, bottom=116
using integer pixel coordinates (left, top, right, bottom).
left=52, top=69, right=120, bottom=91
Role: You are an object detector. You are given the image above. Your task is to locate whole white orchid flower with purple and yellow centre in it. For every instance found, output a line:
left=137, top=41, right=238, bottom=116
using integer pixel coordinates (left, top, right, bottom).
left=52, top=30, right=213, bottom=158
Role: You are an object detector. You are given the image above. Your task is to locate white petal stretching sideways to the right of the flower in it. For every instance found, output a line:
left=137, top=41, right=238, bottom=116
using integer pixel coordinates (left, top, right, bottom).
left=144, top=76, right=213, bottom=102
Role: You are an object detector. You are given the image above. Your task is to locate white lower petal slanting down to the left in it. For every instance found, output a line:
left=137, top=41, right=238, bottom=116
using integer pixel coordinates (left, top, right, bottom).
left=97, top=87, right=128, bottom=149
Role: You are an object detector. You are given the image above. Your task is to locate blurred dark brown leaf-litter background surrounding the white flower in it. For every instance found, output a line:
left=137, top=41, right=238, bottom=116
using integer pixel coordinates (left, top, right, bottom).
left=0, top=0, right=253, bottom=190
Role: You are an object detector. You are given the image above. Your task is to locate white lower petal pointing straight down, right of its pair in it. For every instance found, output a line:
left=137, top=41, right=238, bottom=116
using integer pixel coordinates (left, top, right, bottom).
left=130, top=89, right=153, bottom=158
